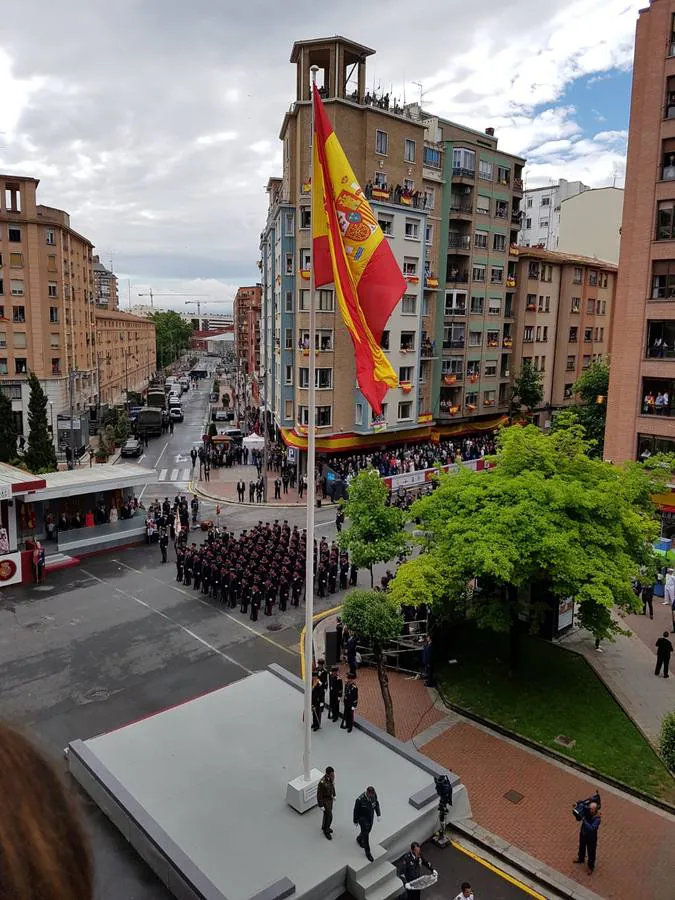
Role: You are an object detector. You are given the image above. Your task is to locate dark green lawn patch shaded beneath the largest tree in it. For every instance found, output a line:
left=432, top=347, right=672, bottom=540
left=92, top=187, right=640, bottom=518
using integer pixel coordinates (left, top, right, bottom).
left=438, top=626, right=675, bottom=803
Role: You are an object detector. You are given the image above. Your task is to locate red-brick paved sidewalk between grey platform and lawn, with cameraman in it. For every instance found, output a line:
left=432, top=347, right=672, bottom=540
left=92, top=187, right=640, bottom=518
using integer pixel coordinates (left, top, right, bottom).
left=315, top=611, right=675, bottom=900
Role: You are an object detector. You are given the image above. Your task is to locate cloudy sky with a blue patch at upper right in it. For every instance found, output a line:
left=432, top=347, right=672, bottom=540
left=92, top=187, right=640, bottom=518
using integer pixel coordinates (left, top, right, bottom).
left=0, top=0, right=645, bottom=312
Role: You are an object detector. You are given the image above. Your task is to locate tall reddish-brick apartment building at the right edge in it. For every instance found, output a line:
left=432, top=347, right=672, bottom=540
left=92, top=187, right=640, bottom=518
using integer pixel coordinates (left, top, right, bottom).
left=605, top=0, right=675, bottom=463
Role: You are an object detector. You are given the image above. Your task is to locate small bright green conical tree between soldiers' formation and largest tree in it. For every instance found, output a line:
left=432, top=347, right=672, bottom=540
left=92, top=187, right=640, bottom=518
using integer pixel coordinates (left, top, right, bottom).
left=338, top=469, right=408, bottom=587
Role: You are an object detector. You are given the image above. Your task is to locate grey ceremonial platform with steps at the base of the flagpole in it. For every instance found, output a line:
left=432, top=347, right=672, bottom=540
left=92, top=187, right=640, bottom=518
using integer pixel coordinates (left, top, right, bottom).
left=68, top=665, right=471, bottom=900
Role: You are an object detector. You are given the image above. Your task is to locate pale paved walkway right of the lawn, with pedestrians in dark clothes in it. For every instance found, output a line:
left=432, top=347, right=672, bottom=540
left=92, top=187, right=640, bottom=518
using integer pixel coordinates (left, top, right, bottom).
left=560, top=612, right=675, bottom=746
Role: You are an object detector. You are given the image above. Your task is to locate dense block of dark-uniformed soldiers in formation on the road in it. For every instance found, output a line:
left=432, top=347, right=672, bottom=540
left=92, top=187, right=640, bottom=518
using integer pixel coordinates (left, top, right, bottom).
left=176, top=519, right=357, bottom=622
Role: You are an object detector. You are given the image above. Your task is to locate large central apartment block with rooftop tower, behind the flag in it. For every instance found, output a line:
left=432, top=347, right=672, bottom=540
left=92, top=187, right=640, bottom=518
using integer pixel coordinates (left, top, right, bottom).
left=261, top=37, right=524, bottom=460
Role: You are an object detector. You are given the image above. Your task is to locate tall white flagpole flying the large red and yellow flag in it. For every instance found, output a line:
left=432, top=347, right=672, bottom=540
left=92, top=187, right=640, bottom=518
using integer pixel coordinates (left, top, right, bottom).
left=303, top=66, right=319, bottom=781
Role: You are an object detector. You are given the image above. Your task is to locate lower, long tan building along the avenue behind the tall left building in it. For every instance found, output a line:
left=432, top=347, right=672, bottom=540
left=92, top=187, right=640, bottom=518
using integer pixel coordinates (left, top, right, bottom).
left=95, top=309, right=157, bottom=406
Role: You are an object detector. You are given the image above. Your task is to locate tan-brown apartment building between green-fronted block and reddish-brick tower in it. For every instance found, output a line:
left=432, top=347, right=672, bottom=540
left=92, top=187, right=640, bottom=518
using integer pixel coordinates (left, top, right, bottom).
left=512, top=247, right=616, bottom=427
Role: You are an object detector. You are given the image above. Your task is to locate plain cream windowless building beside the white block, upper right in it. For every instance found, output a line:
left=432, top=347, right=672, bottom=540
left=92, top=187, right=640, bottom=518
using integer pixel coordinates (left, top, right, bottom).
left=558, top=187, right=623, bottom=265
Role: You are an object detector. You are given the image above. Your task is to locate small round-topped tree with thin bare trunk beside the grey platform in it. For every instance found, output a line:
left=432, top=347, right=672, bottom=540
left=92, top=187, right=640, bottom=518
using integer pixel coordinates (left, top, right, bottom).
left=341, top=589, right=403, bottom=737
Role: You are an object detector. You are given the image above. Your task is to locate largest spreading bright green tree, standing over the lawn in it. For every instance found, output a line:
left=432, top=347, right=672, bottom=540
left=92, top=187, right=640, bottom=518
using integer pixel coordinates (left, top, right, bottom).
left=392, top=425, right=671, bottom=668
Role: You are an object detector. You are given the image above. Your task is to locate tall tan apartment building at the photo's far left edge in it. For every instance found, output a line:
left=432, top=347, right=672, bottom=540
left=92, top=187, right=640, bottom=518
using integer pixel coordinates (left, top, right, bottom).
left=0, top=175, right=98, bottom=436
